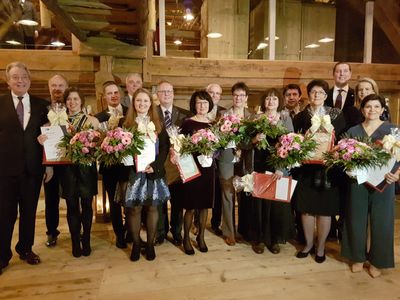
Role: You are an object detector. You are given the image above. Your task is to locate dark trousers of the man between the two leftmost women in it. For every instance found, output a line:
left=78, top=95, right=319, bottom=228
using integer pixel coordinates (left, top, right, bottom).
left=103, top=170, right=125, bottom=238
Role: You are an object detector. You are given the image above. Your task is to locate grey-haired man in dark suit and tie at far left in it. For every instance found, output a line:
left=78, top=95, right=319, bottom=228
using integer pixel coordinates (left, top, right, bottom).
left=0, top=62, right=48, bottom=273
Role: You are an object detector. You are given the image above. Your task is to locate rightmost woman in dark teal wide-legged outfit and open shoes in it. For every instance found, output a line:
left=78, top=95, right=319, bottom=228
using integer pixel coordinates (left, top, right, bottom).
left=342, top=94, right=400, bottom=277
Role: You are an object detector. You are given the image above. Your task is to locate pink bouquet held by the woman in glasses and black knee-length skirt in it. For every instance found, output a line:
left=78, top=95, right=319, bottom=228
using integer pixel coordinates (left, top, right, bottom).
left=268, top=132, right=317, bottom=169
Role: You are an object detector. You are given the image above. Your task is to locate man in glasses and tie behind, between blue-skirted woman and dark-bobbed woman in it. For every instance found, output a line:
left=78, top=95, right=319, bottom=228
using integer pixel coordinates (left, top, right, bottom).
left=155, top=81, right=190, bottom=245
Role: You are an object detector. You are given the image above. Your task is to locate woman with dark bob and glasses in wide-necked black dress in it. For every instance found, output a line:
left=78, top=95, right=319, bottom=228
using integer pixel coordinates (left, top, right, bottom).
left=181, top=90, right=215, bottom=255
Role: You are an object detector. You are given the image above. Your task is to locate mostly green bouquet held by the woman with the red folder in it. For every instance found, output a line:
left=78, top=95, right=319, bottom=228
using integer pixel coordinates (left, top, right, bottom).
left=239, top=115, right=288, bottom=150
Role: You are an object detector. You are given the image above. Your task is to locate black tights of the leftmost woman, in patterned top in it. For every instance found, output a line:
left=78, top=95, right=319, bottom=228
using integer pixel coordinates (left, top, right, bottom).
left=66, top=197, right=93, bottom=238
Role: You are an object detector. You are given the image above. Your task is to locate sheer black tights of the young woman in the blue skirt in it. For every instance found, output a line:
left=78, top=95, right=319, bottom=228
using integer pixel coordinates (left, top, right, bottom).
left=128, top=206, right=158, bottom=246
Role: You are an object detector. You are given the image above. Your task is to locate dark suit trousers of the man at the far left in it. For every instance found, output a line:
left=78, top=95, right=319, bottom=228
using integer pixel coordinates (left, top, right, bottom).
left=0, top=174, right=43, bottom=264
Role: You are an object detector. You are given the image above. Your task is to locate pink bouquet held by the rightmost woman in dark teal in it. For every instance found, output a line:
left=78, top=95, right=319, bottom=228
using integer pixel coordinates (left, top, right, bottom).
left=324, top=137, right=390, bottom=171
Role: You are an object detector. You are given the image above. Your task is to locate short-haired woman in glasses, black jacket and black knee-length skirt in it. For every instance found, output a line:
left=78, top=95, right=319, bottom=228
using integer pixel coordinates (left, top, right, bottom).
left=293, top=79, right=346, bottom=263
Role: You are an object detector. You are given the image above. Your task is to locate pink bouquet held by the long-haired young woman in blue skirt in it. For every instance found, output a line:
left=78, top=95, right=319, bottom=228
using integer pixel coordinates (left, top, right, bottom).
left=97, top=127, right=144, bottom=167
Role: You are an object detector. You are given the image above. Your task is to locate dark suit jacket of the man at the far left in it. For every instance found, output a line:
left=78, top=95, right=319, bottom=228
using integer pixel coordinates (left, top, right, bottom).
left=0, top=93, right=49, bottom=176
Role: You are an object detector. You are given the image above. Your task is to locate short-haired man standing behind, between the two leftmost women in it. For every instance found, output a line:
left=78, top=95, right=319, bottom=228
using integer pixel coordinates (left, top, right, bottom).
left=95, top=81, right=128, bottom=248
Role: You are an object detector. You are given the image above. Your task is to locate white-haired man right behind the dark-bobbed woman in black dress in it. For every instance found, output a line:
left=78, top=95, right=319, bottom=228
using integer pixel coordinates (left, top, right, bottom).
left=206, top=83, right=225, bottom=236
